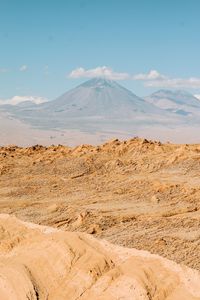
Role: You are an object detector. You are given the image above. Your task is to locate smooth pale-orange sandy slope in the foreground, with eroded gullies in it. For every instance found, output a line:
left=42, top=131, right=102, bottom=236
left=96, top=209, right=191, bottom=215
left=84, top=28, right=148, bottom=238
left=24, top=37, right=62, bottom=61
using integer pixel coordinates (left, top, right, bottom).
left=0, top=215, right=200, bottom=300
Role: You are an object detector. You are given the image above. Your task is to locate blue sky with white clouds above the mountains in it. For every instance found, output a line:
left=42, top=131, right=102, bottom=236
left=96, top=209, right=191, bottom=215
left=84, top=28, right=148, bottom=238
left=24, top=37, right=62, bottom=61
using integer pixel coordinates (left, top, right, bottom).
left=0, top=0, right=200, bottom=101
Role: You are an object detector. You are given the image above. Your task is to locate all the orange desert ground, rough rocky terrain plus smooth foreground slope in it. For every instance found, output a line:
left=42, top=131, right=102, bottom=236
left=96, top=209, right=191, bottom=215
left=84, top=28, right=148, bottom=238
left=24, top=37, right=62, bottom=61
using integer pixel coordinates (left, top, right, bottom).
left=0, top=138, right=200, bottom=300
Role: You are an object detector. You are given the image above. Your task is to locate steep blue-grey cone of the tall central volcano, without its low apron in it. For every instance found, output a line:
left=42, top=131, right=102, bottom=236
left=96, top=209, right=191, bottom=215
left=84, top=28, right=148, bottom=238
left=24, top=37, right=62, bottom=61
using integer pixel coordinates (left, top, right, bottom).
left=40, top=78, right=162, bottom=118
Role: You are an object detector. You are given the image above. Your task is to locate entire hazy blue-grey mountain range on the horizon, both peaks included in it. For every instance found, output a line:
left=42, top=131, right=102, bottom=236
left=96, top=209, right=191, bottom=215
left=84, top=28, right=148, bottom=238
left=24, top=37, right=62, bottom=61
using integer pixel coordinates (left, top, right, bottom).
left=0, top=78, right=200, bottom=145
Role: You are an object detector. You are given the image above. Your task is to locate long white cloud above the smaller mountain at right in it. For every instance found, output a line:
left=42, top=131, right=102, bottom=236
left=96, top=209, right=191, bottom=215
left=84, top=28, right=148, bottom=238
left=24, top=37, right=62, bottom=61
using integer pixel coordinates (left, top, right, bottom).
left=133, top=70, right=200, bottom=88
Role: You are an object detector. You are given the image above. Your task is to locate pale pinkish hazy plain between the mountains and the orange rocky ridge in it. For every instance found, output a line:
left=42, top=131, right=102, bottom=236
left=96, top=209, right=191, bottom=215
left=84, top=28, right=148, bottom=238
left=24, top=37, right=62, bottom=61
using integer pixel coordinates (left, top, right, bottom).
left=0, top=111, right=200, bottom=147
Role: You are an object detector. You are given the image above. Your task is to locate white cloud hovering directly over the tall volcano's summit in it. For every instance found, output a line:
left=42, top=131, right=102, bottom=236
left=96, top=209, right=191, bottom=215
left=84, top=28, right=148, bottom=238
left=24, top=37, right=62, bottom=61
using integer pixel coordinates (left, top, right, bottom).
left=68, top=66, right=130, bottom=80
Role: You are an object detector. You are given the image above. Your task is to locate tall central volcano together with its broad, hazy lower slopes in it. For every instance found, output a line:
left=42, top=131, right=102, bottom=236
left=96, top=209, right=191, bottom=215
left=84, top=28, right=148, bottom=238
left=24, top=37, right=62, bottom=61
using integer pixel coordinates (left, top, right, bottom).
left=5, top=78, right=173, bottom=133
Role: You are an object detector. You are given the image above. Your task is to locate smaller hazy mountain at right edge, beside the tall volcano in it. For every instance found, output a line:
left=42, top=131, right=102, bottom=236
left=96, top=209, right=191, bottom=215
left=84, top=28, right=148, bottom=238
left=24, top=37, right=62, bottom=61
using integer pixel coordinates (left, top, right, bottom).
left=145, top=90, right=200, bottom=115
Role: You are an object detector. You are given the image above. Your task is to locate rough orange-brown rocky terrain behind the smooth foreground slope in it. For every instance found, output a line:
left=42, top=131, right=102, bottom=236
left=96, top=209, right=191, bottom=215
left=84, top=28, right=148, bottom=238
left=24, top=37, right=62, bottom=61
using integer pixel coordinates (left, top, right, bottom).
left=0, top=138, right=200, bottom=270
